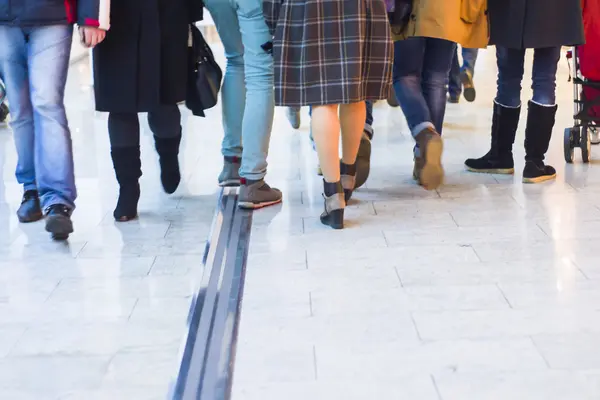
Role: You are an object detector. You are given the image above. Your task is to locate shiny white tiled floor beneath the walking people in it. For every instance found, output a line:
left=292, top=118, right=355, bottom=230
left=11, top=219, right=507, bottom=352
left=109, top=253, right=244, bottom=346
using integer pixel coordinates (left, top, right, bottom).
left=0, top=49, right=600, bottom=400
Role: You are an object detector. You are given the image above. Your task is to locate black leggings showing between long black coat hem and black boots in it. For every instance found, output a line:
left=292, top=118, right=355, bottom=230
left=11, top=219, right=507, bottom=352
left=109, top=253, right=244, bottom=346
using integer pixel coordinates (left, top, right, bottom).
left=108, top=105, right=181, bottom=148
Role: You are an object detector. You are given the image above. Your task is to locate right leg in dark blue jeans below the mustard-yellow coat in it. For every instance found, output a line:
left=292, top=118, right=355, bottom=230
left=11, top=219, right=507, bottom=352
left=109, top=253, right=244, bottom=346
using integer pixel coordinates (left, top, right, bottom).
left=421, top=39, right=456, bottom=135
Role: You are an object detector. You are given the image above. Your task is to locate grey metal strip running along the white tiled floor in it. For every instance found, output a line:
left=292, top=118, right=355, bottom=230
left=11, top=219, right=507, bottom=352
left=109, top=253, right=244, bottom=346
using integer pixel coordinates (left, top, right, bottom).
left=169, top=188, right=252, bottom=400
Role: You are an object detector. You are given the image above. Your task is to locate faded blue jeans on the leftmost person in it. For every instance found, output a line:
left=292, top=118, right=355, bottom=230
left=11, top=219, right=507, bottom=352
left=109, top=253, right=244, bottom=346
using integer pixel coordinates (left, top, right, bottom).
left=0, top=25, right=77, bottom=208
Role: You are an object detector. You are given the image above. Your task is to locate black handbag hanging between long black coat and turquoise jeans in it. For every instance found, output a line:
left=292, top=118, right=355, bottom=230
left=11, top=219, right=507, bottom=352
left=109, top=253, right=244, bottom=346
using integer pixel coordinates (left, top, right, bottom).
left=185, top=24, right=223, bottom=117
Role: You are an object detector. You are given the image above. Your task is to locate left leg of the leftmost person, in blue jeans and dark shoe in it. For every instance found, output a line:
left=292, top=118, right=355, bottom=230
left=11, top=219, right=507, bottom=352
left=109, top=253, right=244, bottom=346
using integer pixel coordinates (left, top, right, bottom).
left=0, top=26, right=43, bottom=222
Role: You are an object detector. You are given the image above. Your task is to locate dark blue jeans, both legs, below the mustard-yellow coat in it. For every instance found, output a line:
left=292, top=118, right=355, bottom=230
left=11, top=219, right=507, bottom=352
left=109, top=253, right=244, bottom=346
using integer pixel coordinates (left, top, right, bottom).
left=394, top=37, right=456, bottom=156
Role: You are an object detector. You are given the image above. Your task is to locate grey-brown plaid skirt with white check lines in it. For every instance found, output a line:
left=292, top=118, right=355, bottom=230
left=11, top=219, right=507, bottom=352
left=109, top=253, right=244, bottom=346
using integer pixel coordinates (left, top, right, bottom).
left=266, top=0, right=394, bottom=107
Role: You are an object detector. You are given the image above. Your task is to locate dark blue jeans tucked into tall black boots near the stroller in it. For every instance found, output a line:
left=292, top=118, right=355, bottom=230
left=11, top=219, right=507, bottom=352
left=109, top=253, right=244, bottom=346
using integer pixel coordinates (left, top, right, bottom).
left=496, top=47, right=561, bottom=107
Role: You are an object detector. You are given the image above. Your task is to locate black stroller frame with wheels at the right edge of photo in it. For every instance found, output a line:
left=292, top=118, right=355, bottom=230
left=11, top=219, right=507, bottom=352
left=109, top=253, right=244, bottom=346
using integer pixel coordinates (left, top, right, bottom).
left=564, top=47, right=600, bottom=164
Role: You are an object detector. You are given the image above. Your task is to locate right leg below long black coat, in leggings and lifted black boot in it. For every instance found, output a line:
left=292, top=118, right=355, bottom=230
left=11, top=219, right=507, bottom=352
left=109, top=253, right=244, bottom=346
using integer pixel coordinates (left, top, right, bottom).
left=148, top=104, right=181, bottom=194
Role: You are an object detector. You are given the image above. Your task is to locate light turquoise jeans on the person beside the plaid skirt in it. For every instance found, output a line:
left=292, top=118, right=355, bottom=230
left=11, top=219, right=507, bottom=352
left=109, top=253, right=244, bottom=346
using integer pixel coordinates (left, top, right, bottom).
left=204, top=0, right=275, bottom=180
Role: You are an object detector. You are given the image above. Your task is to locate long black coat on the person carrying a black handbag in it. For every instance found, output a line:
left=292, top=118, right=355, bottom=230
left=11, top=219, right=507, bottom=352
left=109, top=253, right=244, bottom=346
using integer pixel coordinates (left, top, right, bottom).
left=94, top=0, right=202, bottom=112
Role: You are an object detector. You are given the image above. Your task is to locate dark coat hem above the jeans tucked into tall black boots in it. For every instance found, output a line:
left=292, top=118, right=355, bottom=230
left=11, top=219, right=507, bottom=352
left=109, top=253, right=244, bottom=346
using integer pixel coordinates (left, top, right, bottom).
left=488, top=0, right=584, bottom=49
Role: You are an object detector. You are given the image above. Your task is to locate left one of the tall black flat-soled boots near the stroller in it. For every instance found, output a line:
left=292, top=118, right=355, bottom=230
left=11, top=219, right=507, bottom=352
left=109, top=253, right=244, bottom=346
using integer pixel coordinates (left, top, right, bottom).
left=465, top=102, right=521, bottom=174
